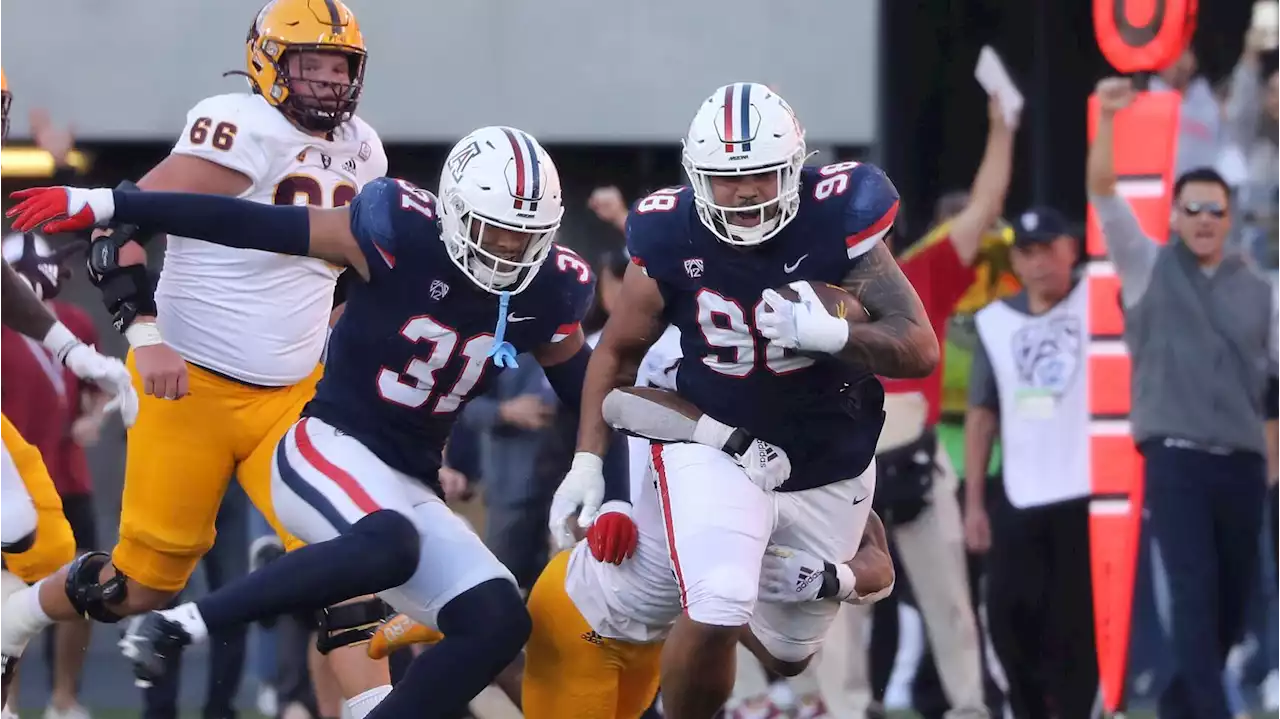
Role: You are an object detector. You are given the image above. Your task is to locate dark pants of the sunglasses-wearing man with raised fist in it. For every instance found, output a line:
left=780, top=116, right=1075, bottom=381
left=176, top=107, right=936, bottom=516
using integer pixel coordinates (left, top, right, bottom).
left=1142, top=440, right=1266, bottom=719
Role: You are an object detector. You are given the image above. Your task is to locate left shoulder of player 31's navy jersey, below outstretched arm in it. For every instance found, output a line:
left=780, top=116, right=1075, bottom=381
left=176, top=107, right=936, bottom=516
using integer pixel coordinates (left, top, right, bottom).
left=351, top=178, right=440, bottom=279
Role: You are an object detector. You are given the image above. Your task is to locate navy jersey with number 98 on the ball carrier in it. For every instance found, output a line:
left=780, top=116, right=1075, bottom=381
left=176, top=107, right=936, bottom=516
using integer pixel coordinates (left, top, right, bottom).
left=627, top=162, right=897, bottom=491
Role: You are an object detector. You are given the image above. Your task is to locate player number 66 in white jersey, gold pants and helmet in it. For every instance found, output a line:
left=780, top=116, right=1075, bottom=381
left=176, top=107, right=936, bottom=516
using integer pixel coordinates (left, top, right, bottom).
left=0, top=0, right=389, bottom=719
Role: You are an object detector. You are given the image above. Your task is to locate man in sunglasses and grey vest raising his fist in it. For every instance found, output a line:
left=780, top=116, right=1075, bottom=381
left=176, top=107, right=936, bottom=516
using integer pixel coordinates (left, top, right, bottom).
left=1087, top=78, right=1280, bottom=719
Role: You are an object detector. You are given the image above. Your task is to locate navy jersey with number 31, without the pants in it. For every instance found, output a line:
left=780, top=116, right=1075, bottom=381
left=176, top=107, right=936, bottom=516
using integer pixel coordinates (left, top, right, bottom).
left=303, top=178, right=595, bottom=486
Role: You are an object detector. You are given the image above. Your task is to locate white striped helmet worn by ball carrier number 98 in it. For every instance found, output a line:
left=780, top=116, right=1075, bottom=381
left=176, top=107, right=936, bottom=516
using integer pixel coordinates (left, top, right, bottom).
left=684, top=82, right=806, bottom=246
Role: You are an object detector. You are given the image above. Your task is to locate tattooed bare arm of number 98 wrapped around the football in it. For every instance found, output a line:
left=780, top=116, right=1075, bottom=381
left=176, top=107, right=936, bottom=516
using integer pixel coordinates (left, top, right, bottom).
left=836, top=242, right=942, bottom=377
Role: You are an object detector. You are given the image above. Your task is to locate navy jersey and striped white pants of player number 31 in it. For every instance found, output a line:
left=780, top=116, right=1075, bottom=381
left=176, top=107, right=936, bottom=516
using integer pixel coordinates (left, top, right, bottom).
left=274, top=178, right=595, bottom=627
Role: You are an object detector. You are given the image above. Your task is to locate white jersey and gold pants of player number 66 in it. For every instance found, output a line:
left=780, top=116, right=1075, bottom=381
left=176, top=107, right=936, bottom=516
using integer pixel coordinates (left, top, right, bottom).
left=122, top=95, right=387, bottom=591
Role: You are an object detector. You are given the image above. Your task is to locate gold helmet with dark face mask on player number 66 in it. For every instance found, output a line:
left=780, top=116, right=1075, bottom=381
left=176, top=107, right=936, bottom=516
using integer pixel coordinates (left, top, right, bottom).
left=246, top=0, right=366, bottom=132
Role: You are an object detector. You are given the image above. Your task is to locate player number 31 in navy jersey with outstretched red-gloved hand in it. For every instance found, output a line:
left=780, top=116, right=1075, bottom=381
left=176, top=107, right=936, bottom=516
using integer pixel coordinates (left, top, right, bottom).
left=9, top=127, right=635, bottom=718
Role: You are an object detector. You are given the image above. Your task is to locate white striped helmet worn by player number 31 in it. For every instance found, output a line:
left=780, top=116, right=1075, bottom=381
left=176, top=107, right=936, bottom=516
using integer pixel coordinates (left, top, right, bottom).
left=439, top=127, right=564, bottom=294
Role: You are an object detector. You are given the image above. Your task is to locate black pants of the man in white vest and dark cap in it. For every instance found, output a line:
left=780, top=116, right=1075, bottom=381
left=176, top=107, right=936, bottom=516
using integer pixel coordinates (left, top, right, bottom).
left=987, top=491, right=1098, bottom=719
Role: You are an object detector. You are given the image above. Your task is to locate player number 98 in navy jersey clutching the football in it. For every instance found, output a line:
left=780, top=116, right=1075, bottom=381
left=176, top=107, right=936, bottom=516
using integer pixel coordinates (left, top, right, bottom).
left=550, top=83, right=938, bottom=719
